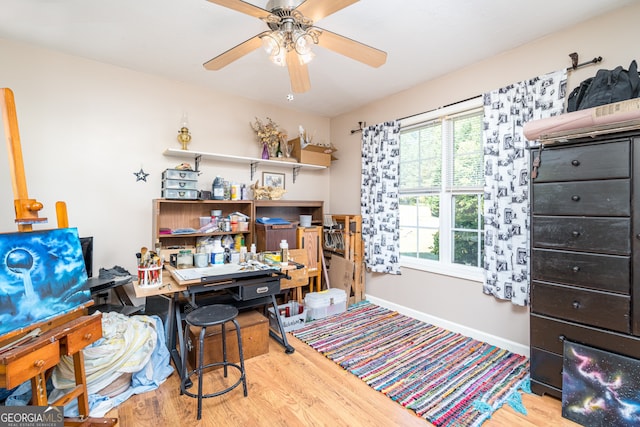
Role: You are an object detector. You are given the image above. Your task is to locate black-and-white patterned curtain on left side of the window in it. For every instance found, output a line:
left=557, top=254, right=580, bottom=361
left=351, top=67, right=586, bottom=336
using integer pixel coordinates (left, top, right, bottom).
left=360, top=121, right=400, bottom=274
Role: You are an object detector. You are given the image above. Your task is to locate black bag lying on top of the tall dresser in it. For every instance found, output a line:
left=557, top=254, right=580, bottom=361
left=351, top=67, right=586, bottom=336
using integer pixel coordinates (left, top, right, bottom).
left=567, top=60, right=640, bottom=112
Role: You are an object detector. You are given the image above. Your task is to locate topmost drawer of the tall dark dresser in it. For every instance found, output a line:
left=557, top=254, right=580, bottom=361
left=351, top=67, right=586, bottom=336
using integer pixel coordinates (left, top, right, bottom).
left=532, top=140, right=631, bottom=182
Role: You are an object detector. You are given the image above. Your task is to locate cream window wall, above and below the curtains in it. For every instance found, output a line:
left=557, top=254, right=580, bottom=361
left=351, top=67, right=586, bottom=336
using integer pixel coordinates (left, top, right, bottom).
left=331, top=3, right=640, bottom=352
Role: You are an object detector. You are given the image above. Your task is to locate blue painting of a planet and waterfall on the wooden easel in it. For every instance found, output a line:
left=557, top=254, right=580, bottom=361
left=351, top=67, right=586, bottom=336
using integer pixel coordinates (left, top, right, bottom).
left=0, top=228, right=91, bottom=336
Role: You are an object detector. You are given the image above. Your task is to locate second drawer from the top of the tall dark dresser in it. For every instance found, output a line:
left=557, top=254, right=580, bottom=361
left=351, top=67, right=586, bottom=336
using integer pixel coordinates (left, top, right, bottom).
left=533, top=179, right=631, bottom=216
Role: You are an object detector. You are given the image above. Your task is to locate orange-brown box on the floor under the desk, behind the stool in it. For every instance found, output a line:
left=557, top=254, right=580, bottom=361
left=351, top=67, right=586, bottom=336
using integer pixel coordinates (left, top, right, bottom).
left=187, top=310, right=269, bottom=369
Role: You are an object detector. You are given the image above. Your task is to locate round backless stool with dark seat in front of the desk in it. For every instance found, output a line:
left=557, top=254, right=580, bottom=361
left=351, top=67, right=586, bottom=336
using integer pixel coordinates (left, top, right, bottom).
left=180, top=304, right=247, bottom=419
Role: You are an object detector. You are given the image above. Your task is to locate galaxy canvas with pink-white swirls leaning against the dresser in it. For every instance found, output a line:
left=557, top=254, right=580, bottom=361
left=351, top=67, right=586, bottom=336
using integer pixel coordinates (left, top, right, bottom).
left=562, top=341, right=640, bottom=427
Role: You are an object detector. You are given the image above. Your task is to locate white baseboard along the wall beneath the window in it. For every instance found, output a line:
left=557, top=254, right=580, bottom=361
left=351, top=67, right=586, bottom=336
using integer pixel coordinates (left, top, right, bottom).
left=365, top=295, right=529, bottom=357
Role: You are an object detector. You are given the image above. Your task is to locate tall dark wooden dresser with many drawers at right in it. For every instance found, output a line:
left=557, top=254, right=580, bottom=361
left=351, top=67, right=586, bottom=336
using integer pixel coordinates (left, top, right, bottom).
left=530, top=131, right=640, bottom=398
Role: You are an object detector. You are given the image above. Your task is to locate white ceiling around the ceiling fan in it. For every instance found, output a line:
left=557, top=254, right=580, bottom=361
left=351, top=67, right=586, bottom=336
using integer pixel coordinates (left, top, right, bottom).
left=0, top=0, right=635, bottom=117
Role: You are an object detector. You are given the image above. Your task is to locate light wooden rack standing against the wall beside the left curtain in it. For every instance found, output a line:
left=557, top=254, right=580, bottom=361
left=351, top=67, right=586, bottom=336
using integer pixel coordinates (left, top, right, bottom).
left=322, top=214, right=365, bottom=304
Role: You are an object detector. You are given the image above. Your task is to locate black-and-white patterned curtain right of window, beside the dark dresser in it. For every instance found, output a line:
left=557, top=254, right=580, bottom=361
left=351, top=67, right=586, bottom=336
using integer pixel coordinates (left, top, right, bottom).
left=483, top=70, right=567, bottom=306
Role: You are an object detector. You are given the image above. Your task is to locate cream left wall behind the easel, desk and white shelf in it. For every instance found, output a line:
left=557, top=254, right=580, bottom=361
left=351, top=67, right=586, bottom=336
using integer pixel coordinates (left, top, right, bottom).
left=0, top=39, right=330, bottom=280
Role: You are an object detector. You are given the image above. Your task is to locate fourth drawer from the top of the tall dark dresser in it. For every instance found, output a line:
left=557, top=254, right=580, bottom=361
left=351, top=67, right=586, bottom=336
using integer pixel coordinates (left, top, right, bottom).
left=531, top=249, right=631, bottom=295
